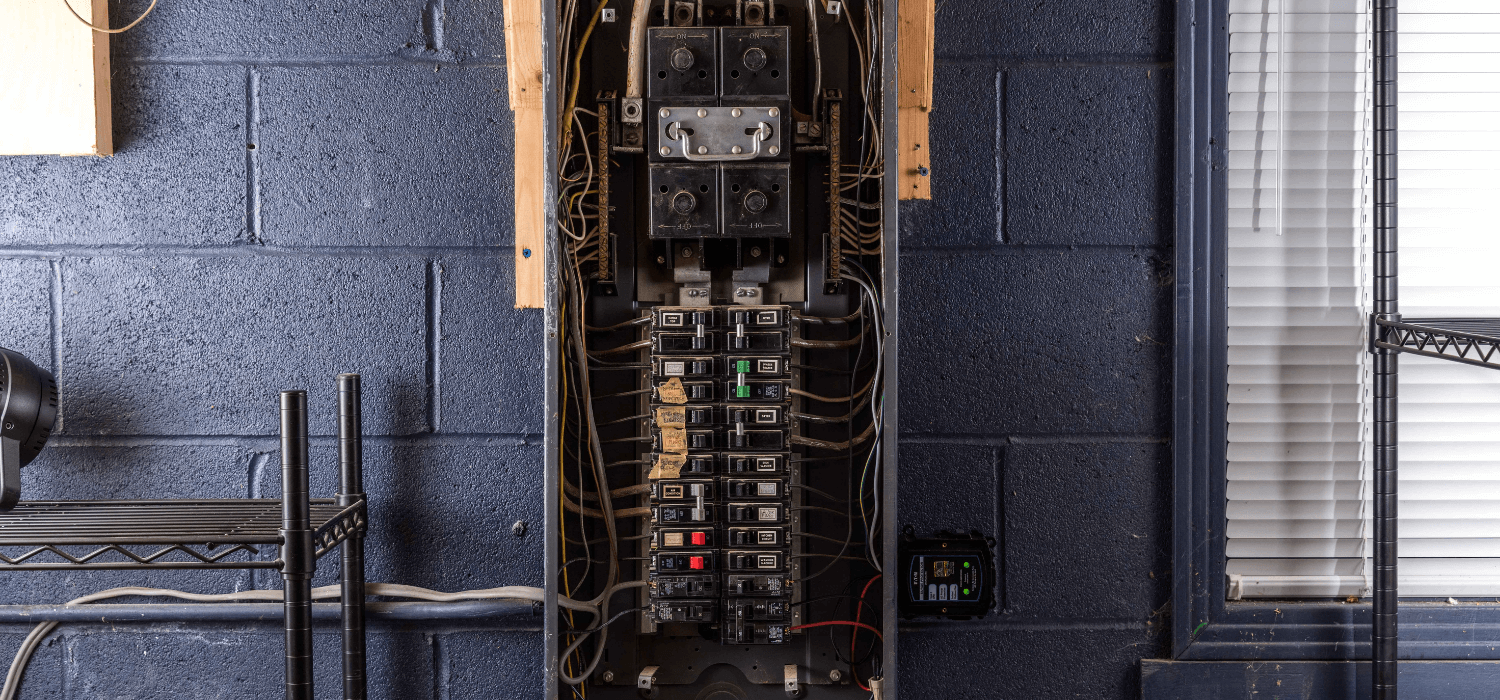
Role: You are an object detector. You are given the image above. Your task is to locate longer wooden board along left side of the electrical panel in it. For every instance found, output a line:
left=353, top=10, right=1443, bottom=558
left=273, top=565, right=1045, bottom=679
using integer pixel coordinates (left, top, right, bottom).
left=504, top=0, right=548, bottom=309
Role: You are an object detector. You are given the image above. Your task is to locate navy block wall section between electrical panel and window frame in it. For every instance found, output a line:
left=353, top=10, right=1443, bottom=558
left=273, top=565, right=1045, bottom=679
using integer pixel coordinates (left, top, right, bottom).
left=900, top=0, right=1175, bottom=700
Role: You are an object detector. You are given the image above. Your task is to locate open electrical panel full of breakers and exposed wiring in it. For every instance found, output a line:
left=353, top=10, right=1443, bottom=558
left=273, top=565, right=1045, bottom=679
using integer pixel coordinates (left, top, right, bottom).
left=549, top=0, right=899, bottom=699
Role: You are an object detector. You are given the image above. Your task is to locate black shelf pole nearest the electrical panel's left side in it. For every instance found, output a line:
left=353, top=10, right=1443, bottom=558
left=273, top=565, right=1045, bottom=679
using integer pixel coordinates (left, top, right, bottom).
left=339, top=375, right=369, bottom=700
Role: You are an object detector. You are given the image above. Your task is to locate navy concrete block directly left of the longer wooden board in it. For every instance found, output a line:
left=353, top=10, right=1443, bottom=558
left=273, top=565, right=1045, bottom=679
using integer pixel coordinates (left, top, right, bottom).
left=258, top=64, right=515, bottom=246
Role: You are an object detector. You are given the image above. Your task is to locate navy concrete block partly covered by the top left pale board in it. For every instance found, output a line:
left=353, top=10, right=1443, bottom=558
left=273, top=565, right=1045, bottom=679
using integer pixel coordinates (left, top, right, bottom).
left=0, top=65, right=246, bottom=246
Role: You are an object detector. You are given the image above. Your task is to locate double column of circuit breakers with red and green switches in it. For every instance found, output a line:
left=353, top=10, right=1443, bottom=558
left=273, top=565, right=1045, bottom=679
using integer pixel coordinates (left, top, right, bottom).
left=648, top=306, right=801, bottom=645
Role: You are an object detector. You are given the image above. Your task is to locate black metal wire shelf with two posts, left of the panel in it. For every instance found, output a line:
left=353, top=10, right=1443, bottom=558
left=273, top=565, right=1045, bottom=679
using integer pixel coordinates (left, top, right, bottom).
left=0, top=375, right=369, bottom=700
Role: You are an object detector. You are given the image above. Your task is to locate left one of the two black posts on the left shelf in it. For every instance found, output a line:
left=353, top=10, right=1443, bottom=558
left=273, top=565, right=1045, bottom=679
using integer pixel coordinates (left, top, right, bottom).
left=281, top=391, right=315, bottom=700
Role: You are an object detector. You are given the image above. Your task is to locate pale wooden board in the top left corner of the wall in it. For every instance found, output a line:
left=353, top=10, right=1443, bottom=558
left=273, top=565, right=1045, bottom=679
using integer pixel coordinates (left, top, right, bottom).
left=0, top=0, right=114, bottom=156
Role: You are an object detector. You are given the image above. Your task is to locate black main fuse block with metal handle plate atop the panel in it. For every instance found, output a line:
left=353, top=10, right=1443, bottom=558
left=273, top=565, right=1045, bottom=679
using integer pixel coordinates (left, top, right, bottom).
left=647, top=27, right=809, bottom=238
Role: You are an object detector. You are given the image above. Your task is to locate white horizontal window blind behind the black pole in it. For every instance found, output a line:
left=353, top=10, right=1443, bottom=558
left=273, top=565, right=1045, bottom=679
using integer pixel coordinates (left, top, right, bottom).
left=1227, top=0, right=1500, bottom=598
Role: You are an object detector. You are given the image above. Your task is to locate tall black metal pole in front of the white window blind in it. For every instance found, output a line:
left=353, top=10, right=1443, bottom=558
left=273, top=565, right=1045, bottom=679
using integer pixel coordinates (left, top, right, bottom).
left=1370, top=0, right=1401, bottom=700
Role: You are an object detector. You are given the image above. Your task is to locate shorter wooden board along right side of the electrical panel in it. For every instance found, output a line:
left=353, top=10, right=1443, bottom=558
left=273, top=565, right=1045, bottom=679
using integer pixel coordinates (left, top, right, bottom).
left=896, top=0, right=936, bottom=199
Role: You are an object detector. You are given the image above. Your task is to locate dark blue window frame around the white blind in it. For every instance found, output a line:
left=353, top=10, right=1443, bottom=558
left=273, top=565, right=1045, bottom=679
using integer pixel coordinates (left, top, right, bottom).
left=1172, top=0, right=1500, bottom=661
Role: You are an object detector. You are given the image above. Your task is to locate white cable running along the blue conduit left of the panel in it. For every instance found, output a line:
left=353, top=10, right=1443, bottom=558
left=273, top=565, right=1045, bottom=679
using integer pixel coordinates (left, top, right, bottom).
left=0, top=582, right=603, bottom=700
